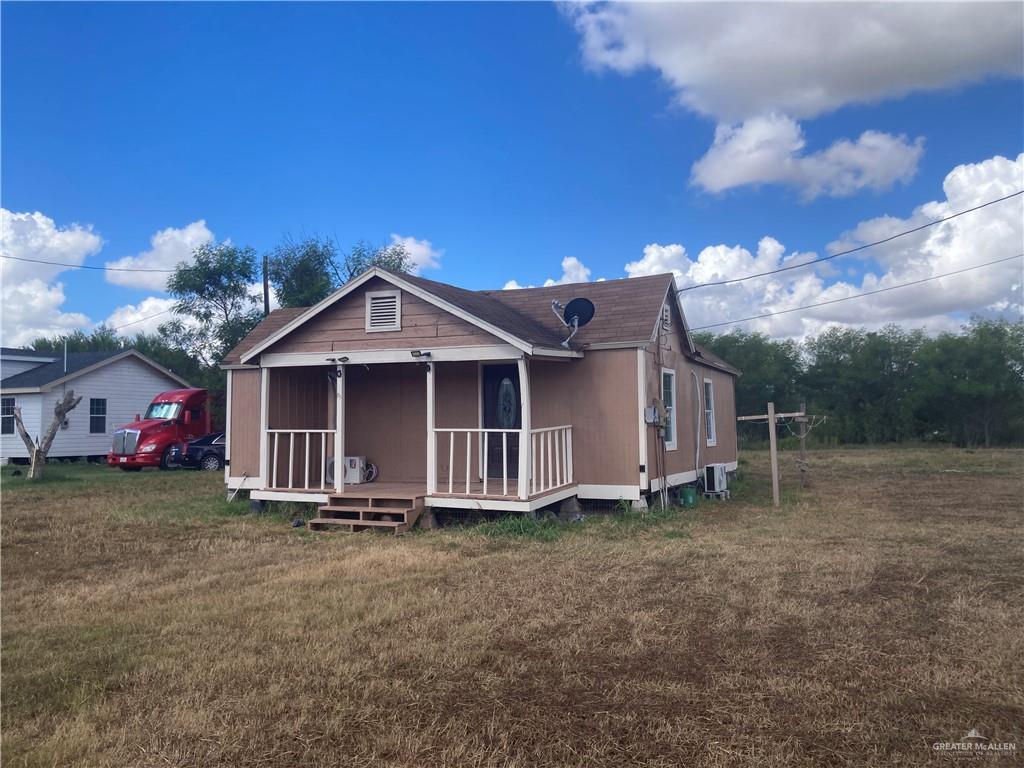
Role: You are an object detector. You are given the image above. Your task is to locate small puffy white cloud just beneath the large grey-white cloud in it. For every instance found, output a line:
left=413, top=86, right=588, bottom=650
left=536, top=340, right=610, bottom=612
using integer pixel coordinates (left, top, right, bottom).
left=691, top=115, right=924, bottom=200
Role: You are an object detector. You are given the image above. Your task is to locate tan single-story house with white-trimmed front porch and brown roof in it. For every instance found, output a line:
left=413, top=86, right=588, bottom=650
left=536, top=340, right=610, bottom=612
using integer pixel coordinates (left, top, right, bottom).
left=223, top=268, right=738, bottom=521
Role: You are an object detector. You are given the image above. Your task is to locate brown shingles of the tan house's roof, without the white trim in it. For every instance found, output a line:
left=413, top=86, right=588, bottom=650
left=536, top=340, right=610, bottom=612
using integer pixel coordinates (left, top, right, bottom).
left=222, top=269, right=736, bottom=373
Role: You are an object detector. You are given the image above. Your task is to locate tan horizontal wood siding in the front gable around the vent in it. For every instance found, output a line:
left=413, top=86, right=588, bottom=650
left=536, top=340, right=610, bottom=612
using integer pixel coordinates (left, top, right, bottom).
left=266, top=278, right=502, bottom=352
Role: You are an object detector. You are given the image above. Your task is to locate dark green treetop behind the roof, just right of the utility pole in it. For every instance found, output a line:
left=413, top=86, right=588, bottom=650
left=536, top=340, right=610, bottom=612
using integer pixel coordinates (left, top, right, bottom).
left=267, top=238, right=341, bottom=307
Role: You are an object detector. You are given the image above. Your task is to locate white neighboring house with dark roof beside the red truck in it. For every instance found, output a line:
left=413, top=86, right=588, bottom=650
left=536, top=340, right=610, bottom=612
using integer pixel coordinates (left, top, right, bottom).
left=0, top=347, right=189, bottom=464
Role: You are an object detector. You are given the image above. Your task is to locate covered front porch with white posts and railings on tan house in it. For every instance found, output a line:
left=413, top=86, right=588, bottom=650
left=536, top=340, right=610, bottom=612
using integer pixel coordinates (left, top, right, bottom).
left=252, top=350, right=575, bottom=511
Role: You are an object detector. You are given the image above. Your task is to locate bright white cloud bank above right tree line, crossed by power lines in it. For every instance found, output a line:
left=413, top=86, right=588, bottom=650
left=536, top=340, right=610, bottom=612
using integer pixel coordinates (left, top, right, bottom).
left=626, top=154, right=1024, bottom=337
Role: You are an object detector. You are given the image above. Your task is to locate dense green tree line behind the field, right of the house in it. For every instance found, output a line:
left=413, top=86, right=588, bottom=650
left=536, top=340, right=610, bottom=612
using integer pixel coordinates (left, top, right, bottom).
left=695, top=317, right=1024, bottom=446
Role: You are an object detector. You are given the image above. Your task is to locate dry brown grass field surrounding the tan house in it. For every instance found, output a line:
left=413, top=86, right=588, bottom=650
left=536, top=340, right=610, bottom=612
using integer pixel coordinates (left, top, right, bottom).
left=2, top=449, right=1024, bottom=768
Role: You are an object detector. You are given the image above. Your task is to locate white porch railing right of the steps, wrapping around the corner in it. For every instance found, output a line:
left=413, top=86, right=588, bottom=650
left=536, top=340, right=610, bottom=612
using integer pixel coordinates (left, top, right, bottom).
left=432, top=425, right=572, bottom=498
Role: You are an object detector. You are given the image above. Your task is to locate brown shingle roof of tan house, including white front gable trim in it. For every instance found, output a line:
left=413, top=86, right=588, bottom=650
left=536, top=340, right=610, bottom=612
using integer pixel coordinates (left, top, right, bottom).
left=228, top=267, right=691, bottom=367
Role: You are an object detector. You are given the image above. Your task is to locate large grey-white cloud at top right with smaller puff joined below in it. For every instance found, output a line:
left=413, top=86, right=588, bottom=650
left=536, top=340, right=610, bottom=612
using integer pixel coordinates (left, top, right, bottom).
left=563, top=2, right=1024, bottom=198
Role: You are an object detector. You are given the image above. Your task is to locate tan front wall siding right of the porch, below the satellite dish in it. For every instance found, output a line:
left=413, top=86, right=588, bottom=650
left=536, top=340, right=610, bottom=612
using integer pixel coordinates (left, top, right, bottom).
left=529, top=349, right=640, bottom=485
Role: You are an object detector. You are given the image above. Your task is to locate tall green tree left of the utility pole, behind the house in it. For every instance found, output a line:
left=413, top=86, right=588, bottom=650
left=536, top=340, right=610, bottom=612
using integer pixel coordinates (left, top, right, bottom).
left=160, top=244, right=261, bottom=367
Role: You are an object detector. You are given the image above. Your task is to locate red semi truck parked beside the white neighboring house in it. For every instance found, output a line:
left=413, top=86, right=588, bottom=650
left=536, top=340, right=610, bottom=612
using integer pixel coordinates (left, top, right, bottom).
left=106, top=389, right=210, bottom=472
